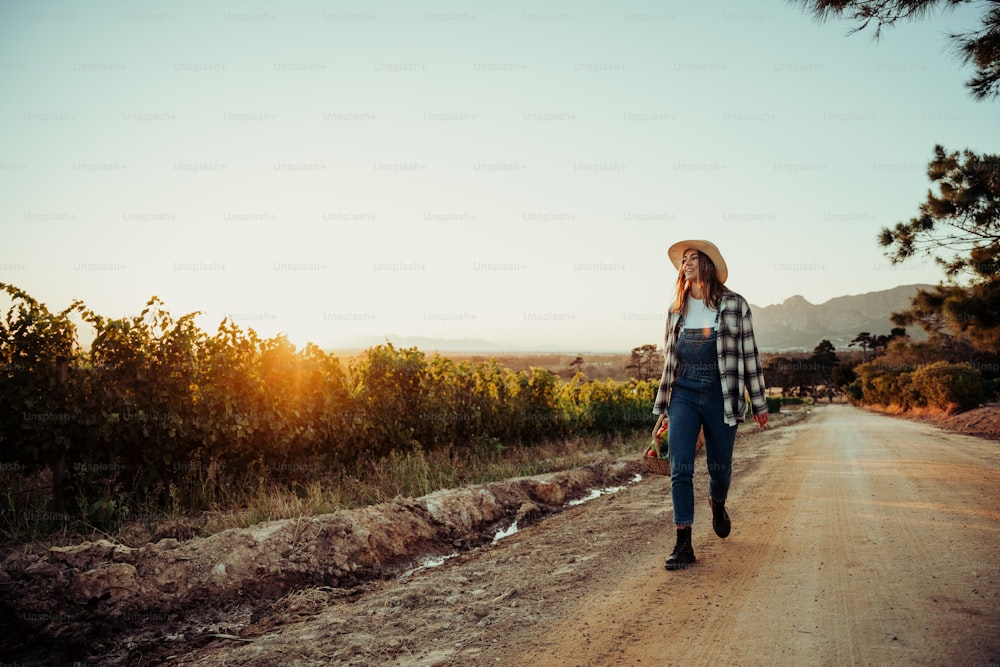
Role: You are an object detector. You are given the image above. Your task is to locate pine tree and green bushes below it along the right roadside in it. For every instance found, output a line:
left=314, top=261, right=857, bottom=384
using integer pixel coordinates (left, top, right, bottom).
left=846, top=146, right=1000, bottom=412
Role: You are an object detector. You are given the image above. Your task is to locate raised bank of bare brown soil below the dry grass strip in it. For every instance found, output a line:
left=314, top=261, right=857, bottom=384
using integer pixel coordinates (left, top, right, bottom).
left=0, top=461, right=640, bottom=660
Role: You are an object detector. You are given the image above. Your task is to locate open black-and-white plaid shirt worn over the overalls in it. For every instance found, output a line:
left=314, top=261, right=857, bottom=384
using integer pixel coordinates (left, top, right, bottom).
left=653, top=290, right=767, bottom=426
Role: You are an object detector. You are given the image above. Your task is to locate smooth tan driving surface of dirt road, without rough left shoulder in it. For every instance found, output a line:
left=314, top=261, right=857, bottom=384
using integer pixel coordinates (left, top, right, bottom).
left=524, top=406, right=1000, bottom=665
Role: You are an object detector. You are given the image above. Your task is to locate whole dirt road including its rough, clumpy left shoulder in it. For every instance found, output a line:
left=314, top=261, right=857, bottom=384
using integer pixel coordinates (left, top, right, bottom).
left=161, top=405, right=1000, bottom=667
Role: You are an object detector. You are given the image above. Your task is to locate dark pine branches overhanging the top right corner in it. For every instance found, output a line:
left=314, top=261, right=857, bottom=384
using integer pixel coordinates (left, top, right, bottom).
left=797, top=0, right=1000, bottom=100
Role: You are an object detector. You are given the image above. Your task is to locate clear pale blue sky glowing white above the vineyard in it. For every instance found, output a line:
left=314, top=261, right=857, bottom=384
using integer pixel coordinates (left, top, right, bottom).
left=0, top=0, right=1000, bottom=352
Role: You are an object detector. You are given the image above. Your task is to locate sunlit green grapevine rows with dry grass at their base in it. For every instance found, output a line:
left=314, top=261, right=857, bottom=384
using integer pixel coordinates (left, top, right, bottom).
left=0, top=285, right=656, bottom=544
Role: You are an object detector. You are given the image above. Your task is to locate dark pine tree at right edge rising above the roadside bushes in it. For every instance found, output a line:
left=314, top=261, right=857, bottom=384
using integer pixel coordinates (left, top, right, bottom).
left=879, top=146, right=1000, bottom=352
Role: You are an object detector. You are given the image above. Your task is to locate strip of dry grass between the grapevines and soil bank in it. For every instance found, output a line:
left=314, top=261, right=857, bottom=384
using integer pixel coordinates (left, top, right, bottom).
left=0, top=434, right=645, bottom=548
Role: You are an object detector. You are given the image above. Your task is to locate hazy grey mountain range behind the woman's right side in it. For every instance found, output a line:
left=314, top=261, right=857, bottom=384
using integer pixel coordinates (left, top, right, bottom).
left=751, top=285, right=933, bottom=352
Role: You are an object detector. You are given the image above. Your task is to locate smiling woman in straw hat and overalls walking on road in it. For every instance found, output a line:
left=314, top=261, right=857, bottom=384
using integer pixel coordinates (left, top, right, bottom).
left=653, top=241, right=767, bottom=570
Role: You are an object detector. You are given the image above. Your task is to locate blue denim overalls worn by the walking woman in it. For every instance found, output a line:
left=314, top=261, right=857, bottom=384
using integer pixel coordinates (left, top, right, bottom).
left=667, top=313, right=736, bottom=526
